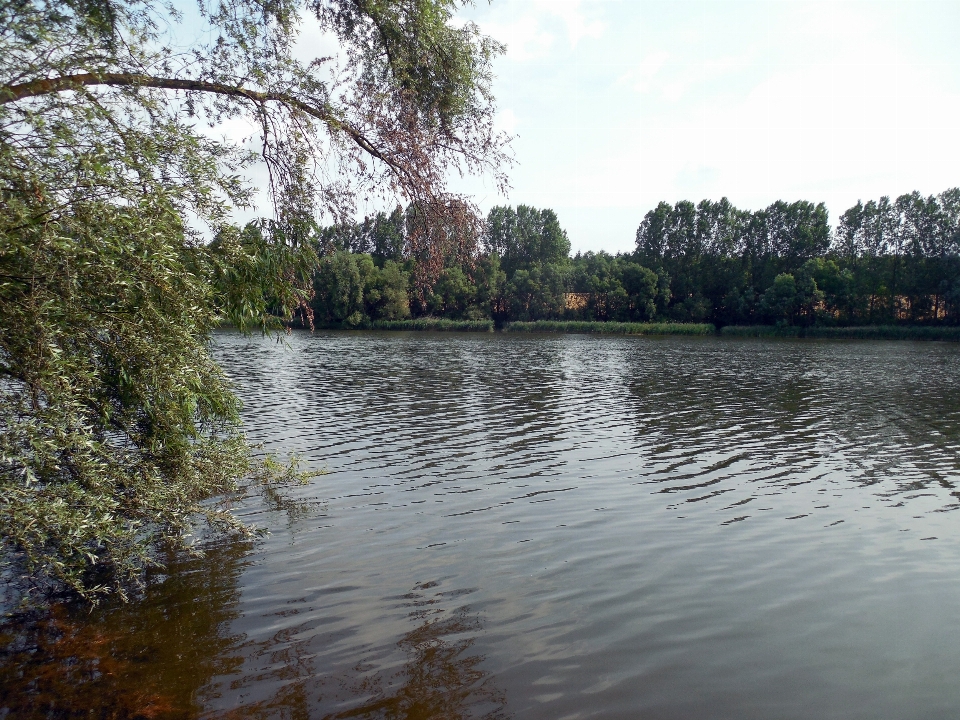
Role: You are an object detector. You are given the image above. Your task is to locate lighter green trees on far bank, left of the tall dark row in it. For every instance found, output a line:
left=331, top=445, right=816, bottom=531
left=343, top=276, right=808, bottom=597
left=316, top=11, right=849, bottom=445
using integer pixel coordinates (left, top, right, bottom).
left=311, top=205, right=669, bottom=328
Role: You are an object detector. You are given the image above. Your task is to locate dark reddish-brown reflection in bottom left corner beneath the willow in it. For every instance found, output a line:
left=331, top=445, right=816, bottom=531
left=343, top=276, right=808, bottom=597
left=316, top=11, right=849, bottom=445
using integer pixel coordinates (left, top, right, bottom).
left=0, top=541, right=251, bottom=720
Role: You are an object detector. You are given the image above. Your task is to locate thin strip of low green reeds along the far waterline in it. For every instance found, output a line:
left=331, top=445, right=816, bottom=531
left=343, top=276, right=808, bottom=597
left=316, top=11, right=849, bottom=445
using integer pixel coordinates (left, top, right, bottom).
left=296, top=317, right=960, bottom=342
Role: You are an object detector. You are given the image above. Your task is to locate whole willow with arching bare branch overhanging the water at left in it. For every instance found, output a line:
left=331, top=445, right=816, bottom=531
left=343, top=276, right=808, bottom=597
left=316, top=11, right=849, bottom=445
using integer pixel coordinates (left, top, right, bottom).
left=0, top=0, right=506, bottom=598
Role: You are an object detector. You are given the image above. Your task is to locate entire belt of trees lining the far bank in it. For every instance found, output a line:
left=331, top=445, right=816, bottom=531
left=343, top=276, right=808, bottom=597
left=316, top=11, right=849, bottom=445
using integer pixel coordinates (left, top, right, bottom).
left=292, top=188, right=960, bottom=327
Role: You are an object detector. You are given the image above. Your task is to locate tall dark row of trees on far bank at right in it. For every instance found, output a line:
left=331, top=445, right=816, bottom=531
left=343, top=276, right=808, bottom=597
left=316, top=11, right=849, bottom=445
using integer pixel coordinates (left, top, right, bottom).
left=634, top=189, right=960, bottom=325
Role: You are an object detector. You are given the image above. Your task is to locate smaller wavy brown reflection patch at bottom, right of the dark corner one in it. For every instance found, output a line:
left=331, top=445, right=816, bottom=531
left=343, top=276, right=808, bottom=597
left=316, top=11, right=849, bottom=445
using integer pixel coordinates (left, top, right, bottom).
left=221, top=583, right=509, bottom=720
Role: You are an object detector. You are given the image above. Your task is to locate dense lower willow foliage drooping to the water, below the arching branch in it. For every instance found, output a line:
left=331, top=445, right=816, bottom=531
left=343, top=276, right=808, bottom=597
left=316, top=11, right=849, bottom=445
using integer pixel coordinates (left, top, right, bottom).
left=0, top=186, right=303, bottom=598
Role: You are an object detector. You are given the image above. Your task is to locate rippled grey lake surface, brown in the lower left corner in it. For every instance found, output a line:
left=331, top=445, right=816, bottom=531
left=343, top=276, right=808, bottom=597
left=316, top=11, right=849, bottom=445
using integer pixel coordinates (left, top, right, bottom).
left=0, top=333, right=960, bottom=719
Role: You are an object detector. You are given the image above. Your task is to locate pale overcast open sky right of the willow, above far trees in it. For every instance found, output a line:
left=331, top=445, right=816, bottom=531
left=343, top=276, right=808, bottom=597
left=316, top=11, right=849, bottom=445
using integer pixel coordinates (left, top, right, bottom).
left=452, top=0, right=960, bottom=252
